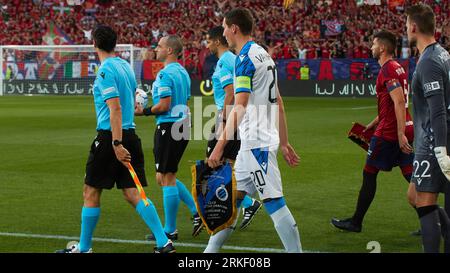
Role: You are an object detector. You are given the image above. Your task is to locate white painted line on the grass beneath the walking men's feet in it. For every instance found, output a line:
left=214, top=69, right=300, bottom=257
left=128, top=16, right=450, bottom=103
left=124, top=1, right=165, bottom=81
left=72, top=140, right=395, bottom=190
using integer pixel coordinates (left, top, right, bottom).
left=0, top=232, right=286, bottom=253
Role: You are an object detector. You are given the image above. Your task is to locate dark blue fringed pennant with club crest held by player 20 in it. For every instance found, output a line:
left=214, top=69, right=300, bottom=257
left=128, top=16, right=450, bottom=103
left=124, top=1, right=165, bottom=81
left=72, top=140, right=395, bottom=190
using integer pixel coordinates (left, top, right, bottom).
left=191, top=160, right=237, bottom=235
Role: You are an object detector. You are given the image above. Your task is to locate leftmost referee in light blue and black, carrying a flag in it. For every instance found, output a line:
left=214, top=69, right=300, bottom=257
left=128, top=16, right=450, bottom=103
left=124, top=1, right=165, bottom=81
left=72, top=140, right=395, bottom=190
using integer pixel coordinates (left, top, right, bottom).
left=56, top=25, right=175, bottom=253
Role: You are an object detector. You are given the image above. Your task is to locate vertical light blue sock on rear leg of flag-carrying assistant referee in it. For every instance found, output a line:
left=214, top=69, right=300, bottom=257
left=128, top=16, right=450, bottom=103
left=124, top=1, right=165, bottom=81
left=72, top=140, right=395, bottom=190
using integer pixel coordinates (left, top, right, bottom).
left=79, top=207, right=100, bottom=252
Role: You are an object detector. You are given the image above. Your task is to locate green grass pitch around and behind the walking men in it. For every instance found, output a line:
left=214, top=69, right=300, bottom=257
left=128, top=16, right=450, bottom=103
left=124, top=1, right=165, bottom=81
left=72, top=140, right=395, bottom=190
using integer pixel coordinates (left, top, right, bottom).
left=0, top=96, right=442, bottom=253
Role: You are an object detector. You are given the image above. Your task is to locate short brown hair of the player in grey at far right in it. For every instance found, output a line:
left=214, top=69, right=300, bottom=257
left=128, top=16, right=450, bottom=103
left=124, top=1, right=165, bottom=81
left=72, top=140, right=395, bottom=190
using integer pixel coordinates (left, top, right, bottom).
left=406, top=4, right=436, bottom=36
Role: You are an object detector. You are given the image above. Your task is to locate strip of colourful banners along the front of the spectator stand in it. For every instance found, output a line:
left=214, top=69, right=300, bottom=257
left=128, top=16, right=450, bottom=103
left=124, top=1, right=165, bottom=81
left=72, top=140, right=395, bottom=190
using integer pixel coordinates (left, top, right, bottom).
left=2, top=56, right=416, bottom=81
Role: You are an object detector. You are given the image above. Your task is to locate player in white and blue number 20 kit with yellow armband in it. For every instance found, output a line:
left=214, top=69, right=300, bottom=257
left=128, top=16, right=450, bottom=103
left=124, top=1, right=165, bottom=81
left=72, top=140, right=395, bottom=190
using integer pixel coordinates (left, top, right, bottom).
left=205, top=8, right=302, bottom=252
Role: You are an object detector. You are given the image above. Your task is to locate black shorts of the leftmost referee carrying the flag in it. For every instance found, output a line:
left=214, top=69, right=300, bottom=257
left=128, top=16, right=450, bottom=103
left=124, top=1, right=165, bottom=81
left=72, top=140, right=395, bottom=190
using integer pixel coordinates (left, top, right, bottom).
left=84, top=129, right=147, bottom=189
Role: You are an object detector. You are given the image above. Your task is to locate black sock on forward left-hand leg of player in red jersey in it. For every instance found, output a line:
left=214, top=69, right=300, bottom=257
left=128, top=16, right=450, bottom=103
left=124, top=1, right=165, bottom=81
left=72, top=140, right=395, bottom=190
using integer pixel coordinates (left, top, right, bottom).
left=352, top=171, right=378, bottom=226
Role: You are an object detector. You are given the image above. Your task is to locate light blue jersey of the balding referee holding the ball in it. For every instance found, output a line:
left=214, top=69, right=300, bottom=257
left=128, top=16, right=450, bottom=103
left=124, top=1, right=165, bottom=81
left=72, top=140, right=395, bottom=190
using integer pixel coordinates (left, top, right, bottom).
left=152, top=62, right=191, bottom=124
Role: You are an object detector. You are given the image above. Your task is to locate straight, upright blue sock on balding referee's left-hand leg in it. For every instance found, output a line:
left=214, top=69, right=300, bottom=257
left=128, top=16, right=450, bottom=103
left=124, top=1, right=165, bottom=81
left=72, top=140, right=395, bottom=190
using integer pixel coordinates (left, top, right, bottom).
left=162, top=186, right=180, bottom=233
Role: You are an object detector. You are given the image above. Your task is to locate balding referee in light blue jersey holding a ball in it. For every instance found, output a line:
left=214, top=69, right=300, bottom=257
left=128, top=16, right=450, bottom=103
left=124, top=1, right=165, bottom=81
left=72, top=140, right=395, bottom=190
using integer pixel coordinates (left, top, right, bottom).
left=135, top=35, right=203, bottom=240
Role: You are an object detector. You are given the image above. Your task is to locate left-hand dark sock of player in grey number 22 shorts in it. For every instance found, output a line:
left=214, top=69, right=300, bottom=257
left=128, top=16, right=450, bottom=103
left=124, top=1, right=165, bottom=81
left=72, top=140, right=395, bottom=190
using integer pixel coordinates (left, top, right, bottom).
left=416, top=205, right=441, bottom=253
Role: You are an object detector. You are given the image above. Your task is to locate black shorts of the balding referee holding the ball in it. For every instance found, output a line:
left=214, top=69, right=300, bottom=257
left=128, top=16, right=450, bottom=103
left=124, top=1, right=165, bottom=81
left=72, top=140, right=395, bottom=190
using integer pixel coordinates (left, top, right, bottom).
left=153, top=119, right=190, bottom=173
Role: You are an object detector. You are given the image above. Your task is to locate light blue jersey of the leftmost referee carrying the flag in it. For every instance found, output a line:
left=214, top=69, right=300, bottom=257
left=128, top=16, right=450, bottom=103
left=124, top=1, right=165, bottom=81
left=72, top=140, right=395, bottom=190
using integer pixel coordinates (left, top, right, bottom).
left=94, top=57, right=137, bottom=130
